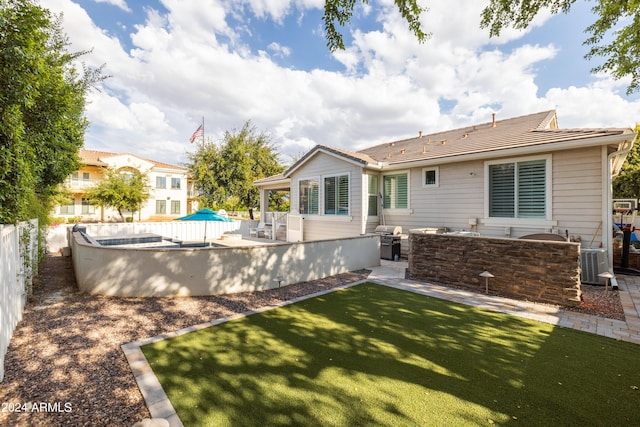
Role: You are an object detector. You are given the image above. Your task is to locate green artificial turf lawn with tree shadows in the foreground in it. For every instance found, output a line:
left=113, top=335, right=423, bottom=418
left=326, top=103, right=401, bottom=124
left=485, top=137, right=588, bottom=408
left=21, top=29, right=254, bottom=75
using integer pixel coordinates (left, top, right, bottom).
left=142, top=283, right=640, bottom=426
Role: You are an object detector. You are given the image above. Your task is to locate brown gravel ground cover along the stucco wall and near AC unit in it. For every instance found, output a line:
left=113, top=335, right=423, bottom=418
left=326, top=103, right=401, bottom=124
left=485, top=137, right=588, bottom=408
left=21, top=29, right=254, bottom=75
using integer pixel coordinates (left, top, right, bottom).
left=0, top=256, right=624, bottom=426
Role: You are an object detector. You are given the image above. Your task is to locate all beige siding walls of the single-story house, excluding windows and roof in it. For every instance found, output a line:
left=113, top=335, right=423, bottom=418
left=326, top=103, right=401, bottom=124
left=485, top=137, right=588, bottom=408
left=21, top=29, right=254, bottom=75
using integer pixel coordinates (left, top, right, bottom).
left=291, top=147, right=607, bottom=260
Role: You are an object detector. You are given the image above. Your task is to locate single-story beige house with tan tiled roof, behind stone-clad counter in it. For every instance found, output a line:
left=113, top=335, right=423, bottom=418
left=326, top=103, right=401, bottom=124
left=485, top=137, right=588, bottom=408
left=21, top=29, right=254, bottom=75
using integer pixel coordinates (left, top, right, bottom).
left=255, top=110, right=636, bottom=268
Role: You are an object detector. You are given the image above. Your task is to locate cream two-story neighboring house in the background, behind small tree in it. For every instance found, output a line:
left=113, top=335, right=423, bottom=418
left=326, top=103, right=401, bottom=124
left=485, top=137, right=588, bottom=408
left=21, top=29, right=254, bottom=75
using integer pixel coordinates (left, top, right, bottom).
left=54, top=150, right=191, bottom=222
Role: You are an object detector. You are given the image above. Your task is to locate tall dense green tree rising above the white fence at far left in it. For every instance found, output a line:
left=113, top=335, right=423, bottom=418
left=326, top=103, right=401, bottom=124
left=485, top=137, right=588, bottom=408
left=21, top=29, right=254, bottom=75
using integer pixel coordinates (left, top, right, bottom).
left=0, top=0, right=102, bottom=223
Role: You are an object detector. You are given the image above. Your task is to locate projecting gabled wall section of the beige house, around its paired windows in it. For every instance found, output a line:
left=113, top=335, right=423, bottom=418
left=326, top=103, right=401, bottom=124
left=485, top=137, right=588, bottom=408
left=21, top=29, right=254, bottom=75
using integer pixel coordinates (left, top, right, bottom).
left=291, top=153, right=363, bottom=240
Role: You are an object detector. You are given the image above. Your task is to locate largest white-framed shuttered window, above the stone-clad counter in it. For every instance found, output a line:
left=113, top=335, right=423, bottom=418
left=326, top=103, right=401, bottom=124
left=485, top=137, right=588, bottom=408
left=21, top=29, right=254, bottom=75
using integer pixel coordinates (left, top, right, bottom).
left=488, top=159, right=547, bottom=218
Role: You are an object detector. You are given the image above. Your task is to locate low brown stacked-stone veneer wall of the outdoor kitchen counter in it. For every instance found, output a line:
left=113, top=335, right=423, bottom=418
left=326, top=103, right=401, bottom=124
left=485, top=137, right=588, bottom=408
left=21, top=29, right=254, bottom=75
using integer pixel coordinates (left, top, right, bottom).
left=408, top=233, right=582, bottom=306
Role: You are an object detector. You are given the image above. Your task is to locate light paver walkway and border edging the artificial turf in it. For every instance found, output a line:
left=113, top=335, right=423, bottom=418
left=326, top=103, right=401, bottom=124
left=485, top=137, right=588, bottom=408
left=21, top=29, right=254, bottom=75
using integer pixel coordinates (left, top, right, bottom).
left=122, top=260, right=640, bottom=427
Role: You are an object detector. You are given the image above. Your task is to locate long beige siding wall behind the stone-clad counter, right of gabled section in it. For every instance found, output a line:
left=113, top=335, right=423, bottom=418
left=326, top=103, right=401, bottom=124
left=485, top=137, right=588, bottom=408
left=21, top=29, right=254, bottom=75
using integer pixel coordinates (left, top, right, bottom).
left=380, top=147, right=603, bottom=247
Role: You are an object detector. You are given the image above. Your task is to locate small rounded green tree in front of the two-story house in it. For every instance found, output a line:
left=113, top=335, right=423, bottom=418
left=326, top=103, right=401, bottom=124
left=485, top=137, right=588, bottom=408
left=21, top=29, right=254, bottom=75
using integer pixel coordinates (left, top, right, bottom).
left=85, top=169, right=151, bottom=221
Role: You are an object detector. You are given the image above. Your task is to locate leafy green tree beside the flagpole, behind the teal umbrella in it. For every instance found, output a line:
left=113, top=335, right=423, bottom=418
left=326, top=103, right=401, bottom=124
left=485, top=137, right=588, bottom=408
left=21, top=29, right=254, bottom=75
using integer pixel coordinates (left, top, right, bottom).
left=187, top=121, right=284, bottom=214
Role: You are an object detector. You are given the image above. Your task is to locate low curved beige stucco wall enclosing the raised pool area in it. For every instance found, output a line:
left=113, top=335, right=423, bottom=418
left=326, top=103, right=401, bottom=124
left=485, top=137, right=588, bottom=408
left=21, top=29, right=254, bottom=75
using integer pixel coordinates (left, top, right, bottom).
left=71, top=232, right=380, bottom=297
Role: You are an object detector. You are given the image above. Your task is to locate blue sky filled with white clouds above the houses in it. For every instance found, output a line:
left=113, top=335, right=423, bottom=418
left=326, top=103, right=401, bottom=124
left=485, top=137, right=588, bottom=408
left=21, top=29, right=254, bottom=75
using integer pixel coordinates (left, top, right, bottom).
left=40, top=0, right=640, bottom=166
